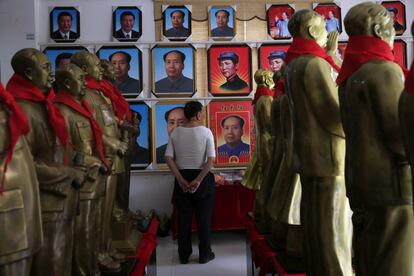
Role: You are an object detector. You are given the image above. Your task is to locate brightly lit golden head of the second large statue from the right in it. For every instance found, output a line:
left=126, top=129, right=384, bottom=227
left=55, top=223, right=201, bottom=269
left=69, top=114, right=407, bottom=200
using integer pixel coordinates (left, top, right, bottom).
left=288, top=10, right=328, bottom=47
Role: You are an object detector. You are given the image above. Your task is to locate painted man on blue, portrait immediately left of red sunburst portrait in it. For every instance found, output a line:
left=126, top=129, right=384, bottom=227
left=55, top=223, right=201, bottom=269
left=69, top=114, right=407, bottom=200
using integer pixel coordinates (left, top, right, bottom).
left=155, top=50, right=194, bottom=93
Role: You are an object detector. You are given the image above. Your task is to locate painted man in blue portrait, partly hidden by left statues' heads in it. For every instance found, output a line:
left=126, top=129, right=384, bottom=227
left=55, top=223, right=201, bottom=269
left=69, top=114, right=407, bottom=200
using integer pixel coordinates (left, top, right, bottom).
left=109, top=51, right=141, bottom=93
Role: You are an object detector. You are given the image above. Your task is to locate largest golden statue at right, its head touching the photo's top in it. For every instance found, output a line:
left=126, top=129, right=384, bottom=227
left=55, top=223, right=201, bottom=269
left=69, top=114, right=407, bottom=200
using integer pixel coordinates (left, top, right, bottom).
left=337, top=2, right=414, bottom=275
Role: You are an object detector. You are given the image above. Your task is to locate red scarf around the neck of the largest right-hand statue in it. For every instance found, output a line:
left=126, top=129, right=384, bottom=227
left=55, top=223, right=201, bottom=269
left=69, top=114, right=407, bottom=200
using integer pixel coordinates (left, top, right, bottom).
left=336, top=35, right=408, bottom=85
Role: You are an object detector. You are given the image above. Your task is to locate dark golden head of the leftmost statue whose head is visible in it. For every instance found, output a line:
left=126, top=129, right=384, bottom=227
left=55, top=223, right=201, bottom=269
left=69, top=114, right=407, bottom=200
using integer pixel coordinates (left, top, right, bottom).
left=11, top=48, right=54, bottom=93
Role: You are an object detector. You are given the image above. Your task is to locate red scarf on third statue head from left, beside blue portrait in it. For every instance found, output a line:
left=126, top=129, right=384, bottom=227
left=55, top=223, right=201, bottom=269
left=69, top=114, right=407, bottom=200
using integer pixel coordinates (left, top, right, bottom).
left=86, top=76, right=132, bottom=122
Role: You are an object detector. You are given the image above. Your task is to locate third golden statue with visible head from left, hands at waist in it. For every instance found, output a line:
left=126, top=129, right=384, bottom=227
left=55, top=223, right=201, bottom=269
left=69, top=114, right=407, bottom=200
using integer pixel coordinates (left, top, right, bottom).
left=71, top=51, right=128, bottom=271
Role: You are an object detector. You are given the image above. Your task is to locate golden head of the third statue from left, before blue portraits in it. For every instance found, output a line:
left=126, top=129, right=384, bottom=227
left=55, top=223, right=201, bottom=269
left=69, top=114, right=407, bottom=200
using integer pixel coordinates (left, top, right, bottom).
left=70, top=51, right=103, bottom=81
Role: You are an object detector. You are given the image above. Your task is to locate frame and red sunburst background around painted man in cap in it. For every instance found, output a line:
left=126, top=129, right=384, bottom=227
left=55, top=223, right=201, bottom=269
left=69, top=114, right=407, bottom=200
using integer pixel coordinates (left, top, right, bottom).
left=207, top=44, right=253, bottom=96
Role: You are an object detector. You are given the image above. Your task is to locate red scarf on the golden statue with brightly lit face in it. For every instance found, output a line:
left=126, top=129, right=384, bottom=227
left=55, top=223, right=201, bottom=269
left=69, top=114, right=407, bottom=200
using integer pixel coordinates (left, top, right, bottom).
left=275, top=37, right=341, bottom=95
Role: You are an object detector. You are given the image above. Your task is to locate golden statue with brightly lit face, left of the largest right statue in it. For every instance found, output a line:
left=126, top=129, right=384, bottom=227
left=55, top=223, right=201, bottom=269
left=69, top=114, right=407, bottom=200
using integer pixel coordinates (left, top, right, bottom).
left=285, top=10, right=352, bottom=276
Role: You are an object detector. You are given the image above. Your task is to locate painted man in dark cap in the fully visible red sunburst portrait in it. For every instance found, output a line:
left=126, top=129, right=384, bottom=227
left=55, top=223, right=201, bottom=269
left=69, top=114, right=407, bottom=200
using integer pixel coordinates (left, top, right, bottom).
left=217, top=52, right=247, bottom=90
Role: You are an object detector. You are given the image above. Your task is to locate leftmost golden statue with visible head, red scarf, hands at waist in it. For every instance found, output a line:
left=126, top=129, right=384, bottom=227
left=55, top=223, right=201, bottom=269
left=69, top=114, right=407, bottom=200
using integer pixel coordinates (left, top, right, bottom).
left=7, top=48, right=85, bottom=275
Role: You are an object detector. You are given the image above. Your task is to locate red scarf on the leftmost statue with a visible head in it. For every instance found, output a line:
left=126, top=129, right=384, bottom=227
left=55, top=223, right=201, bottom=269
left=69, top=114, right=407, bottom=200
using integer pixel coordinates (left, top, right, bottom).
left=6, top=74, right=69, bottom=164
